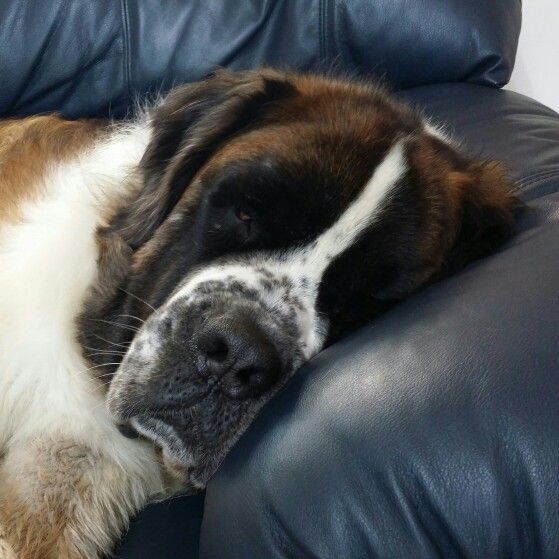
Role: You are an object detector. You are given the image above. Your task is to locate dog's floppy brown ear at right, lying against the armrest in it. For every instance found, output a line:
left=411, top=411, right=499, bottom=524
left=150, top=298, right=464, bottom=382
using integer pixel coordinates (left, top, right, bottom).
left=409, top=135, right=524, bottom=278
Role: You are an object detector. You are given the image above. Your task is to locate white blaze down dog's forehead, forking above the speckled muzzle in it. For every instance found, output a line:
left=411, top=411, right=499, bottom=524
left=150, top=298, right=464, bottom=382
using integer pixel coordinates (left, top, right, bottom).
left=167, top=139, right=408, bottom=358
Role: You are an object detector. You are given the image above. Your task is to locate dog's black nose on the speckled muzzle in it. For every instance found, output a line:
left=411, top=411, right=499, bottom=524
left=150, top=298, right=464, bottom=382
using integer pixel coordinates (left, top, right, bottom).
left=196, top=317, right=282, bottom=400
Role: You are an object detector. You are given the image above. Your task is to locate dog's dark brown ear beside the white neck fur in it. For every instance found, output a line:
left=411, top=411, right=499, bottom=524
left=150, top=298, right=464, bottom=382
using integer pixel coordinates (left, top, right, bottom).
left=111, top=69, right=294, bottom=250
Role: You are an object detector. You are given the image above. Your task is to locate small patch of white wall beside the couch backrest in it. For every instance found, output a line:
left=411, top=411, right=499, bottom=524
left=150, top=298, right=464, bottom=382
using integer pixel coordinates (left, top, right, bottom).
left=508, top=0, right=559, bottom=112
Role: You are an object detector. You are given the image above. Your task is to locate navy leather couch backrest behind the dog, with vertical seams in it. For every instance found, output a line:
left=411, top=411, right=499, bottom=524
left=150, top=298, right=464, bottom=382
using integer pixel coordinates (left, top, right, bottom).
left=0, top=0, right=521, bottom=116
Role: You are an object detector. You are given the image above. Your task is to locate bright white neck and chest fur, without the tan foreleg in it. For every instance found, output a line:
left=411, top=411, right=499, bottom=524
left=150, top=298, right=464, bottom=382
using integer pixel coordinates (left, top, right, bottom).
left=0, top=123, right=158, bottom=468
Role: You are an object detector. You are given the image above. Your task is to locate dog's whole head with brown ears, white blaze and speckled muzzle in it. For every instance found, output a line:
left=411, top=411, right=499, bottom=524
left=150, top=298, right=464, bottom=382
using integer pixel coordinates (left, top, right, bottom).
left=85, top=70, right=516, bottom=490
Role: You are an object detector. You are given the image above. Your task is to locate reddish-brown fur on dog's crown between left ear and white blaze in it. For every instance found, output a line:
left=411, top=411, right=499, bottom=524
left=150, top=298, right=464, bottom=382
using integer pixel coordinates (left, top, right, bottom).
left=202, top=70, right=420, bottom=183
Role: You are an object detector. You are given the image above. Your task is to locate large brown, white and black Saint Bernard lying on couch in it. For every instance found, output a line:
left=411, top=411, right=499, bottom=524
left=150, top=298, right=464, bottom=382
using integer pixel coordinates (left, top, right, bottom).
left=0, top=69, right=519, bottom=559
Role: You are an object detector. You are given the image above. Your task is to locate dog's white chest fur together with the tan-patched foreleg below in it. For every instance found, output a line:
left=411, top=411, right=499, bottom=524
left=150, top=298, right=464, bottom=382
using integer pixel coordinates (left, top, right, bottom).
left=0, top=117, right=164, bottom=559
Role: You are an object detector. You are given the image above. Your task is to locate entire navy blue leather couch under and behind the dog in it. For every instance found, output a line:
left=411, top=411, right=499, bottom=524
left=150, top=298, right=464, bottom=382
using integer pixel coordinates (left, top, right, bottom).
left=0, top=0, right=559, bottom=559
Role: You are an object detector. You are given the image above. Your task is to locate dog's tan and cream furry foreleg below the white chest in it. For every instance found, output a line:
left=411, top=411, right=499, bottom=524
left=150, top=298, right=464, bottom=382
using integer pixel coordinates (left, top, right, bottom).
left=0, top=439, right=163, bottom=559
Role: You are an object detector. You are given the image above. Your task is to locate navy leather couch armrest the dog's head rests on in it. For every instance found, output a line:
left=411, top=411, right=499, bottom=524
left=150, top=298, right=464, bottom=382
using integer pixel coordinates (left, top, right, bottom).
left=201, top=86, right=559, bottom=559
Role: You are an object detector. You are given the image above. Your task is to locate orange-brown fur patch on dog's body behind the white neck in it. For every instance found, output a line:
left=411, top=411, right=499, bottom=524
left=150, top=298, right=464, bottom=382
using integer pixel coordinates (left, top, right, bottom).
left=0, top=115, right=104, bottom=223
